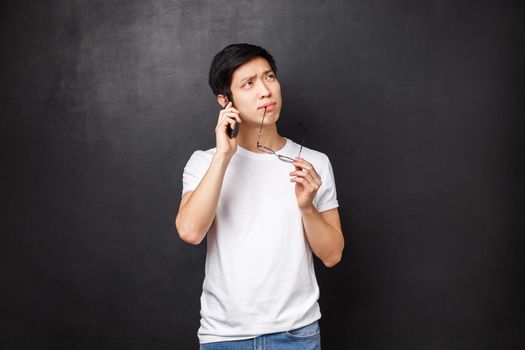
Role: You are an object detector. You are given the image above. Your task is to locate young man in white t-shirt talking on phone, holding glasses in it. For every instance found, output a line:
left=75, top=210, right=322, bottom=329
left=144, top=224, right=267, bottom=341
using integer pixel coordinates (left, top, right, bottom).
left=176, top=44, right=344, bottom=350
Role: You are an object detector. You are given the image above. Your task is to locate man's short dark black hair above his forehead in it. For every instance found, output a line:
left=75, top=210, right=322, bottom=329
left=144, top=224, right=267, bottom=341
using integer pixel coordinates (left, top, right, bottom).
left=208, top=44, right=277, bottom=101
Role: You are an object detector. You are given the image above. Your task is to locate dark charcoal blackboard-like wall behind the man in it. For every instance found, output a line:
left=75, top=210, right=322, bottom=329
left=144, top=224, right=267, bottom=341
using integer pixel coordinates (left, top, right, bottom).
left=0, top=0, right=525, bottom=349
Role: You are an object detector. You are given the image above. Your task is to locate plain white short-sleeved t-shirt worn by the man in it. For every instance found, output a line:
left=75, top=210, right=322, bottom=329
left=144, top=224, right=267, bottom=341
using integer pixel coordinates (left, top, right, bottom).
left=182, top=139, right=339, bottom=344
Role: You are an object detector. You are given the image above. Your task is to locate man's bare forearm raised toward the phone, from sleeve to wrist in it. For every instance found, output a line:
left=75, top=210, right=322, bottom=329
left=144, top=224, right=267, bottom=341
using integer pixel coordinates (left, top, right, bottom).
left=175, top=153, right=231, bottom=245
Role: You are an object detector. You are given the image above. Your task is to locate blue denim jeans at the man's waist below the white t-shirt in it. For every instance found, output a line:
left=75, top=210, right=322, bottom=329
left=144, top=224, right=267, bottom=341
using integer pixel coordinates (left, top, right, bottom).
left=200, top=321, right=321, bottom=350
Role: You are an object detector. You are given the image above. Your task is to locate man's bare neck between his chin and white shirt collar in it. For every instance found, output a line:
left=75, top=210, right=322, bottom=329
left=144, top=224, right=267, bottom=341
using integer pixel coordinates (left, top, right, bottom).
left=237, top=123, right=286, bottom=153
